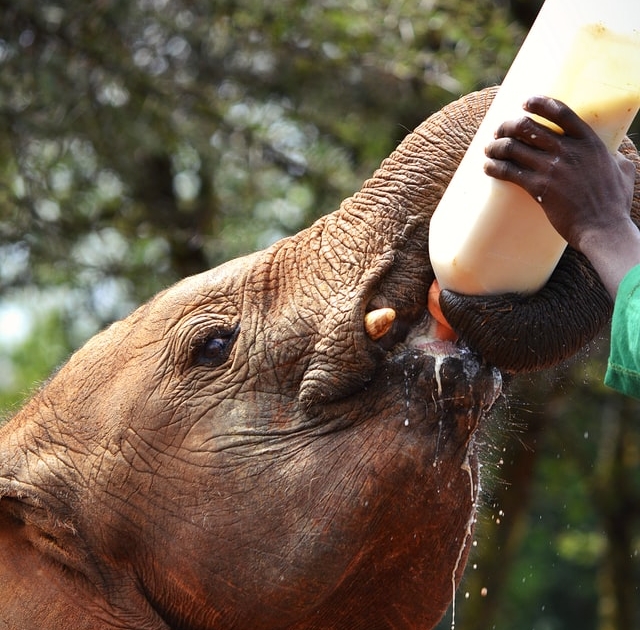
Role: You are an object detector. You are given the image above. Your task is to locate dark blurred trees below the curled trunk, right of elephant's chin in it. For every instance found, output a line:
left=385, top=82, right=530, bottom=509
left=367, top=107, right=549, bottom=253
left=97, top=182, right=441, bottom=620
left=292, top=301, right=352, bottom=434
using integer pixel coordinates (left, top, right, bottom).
left=441, top=350, right=640, bottom=630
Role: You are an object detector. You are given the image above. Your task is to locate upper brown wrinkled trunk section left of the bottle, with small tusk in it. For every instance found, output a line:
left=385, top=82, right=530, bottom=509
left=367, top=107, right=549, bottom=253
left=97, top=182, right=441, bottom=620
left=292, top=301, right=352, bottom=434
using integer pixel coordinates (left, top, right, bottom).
left=294, top=92, right=500, bottom=403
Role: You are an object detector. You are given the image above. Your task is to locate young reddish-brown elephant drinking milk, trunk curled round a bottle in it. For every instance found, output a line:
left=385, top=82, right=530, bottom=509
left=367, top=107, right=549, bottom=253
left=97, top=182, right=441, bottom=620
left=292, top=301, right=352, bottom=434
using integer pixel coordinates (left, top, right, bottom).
left=0, top=88, right=640, bottom=630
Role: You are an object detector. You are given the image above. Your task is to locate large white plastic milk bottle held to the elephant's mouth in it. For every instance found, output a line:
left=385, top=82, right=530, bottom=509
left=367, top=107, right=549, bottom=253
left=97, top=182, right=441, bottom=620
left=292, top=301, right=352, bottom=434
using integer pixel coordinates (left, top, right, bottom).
left=429, top=0, right=640, bottom=295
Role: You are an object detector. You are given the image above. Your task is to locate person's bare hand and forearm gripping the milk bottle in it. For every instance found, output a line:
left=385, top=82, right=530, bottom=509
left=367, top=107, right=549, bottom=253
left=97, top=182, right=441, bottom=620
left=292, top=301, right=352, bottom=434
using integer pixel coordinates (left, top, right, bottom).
left=485, top=96, right=640, bottom=299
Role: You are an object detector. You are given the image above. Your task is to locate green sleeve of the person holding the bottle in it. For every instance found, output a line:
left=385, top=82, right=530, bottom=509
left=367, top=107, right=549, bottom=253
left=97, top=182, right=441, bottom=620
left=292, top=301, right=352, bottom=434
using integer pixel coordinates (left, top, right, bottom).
left=604, top=265, right=640, bottom=398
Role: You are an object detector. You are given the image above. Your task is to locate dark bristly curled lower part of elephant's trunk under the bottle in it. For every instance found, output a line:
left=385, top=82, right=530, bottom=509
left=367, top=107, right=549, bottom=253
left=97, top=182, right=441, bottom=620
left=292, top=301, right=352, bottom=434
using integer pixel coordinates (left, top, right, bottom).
left=440, top=138, right=640, bottom=372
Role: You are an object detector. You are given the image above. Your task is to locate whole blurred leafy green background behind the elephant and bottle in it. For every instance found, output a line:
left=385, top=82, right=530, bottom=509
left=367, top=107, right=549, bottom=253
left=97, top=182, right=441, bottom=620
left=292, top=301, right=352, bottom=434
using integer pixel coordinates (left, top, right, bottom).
left=0, top=0, right=640, bottom=630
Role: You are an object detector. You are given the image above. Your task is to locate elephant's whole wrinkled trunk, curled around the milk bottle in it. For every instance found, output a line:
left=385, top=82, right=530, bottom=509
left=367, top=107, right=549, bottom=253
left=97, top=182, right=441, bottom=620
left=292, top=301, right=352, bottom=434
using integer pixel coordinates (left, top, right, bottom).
left=294, top=88, right=640, bottom=386
